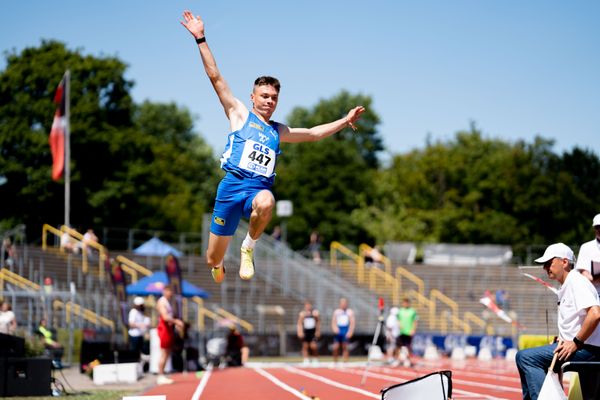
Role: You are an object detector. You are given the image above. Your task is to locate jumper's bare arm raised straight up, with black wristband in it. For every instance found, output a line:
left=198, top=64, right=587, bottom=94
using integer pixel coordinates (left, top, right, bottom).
left=180, top=10, right=249, bottom=130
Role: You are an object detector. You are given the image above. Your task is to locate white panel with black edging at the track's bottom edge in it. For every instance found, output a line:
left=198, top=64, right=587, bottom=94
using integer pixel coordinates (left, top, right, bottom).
left=381, top=371, right=452, bottom=400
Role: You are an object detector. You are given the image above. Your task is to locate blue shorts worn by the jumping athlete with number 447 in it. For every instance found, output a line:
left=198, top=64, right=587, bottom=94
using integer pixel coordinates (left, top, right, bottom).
left=210, top=172, right=270, bottom=236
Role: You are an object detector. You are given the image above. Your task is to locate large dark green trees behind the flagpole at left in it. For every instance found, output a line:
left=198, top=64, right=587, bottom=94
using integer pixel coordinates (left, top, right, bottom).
left=0, top=41, right=216, bottom=233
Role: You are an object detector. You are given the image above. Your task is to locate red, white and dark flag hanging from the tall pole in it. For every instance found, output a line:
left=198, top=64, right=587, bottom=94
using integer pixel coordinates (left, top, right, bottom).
left=48, top=74, right=68, bottom=181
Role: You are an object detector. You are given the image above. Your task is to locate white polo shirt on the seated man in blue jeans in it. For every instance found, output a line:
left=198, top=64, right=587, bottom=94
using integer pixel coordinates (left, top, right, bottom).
left=558, top=271, right=600, bottom=346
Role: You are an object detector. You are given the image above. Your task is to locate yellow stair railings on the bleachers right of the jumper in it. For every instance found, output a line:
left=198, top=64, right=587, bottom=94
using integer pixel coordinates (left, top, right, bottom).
left=330, top=242, right=493, bottom=334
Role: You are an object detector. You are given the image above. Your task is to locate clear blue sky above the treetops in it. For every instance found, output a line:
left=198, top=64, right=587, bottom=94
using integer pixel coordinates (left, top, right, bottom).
left=0, top=0, right=600, bottom=159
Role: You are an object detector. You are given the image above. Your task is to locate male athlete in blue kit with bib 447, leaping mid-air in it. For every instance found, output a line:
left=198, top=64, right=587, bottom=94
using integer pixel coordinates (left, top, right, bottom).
left=181, top=11, right=365, bottom=283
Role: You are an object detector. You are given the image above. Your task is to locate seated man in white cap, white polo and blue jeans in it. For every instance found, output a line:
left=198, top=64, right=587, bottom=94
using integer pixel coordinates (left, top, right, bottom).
left=517, top=243, right=600, bottom=400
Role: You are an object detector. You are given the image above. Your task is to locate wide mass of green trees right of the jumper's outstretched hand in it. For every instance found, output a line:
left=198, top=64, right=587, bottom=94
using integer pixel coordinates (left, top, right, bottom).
left=353, top=125, right=600, bottom=244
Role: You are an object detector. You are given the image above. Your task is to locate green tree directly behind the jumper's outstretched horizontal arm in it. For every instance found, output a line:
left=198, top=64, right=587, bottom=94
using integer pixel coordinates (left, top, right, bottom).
left=274, top=91, right=382, bottom=249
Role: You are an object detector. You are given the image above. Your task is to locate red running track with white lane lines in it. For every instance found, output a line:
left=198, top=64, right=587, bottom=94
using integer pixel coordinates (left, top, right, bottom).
left=145, top=359, right=522, bottom=400
